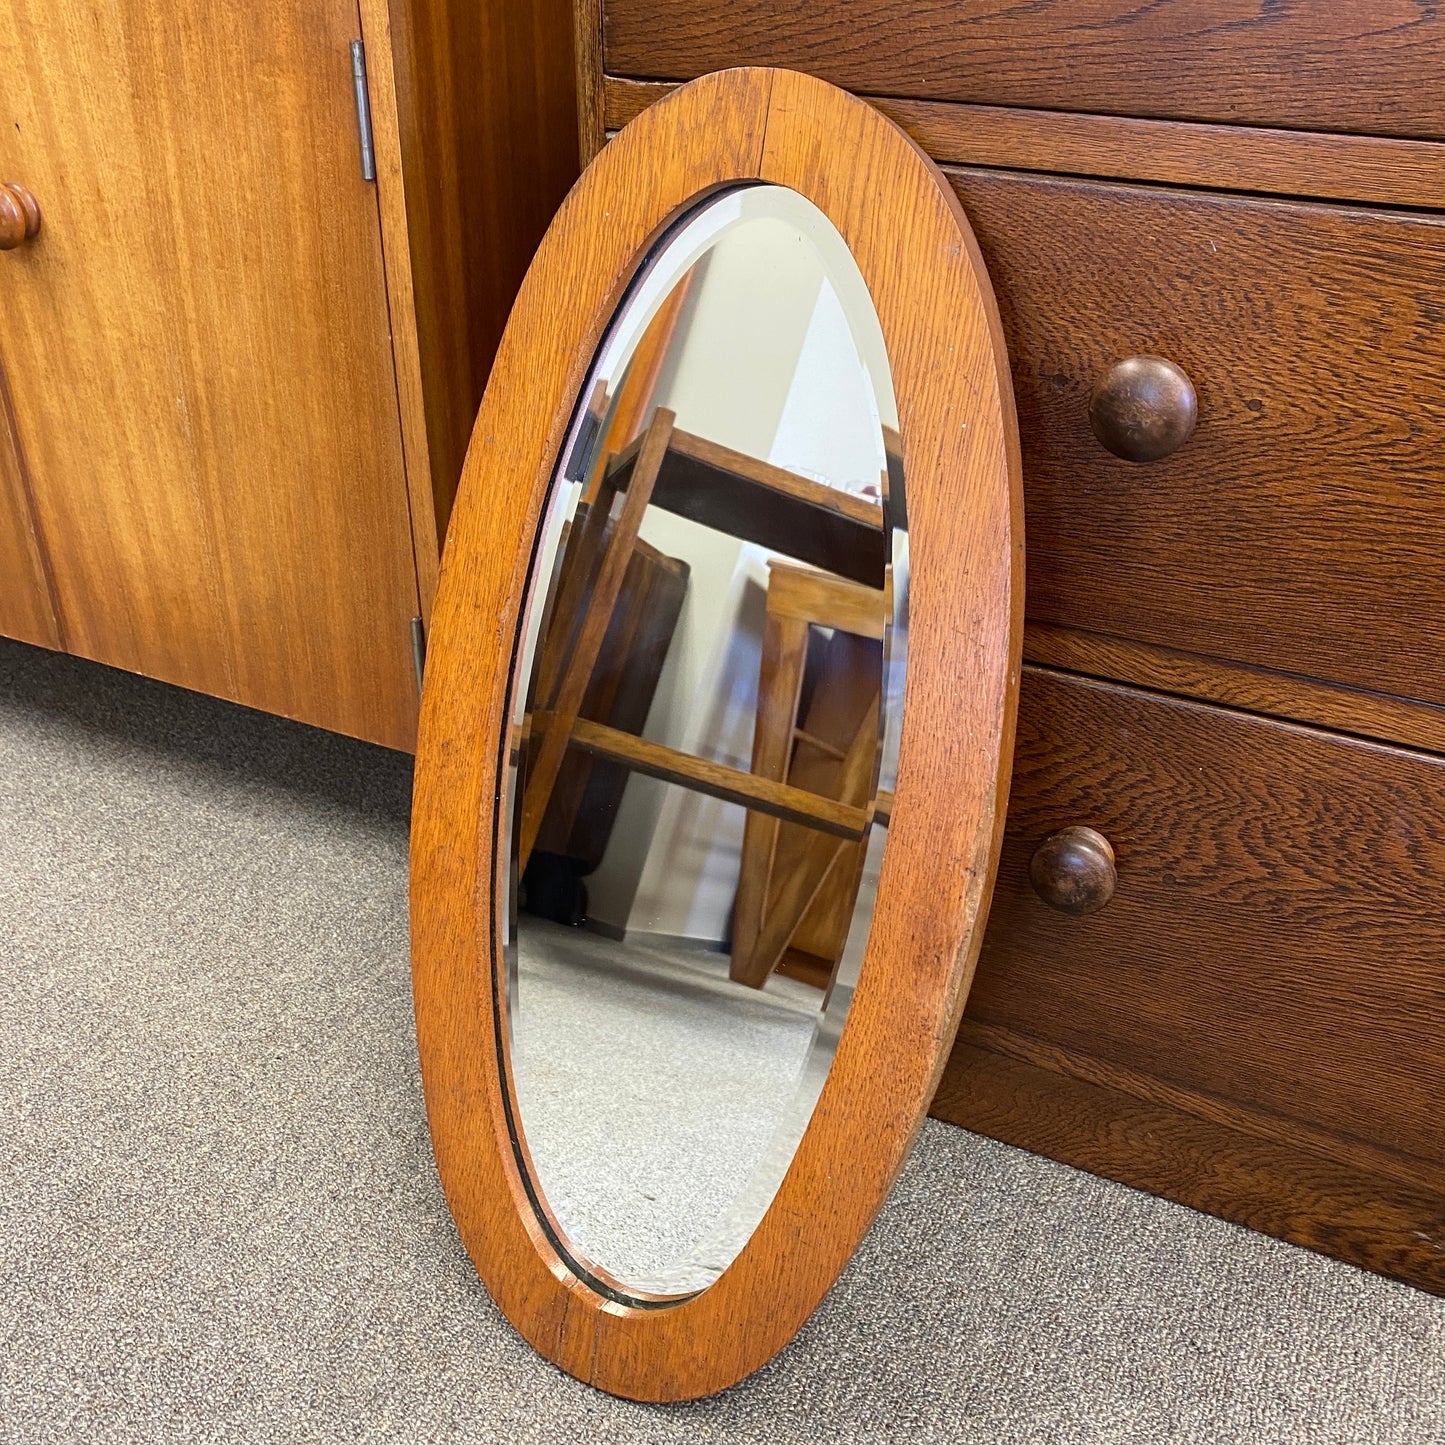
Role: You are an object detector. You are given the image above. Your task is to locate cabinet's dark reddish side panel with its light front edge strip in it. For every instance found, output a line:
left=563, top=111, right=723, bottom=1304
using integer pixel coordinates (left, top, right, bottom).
left=361, top=0, right=579, bottom=586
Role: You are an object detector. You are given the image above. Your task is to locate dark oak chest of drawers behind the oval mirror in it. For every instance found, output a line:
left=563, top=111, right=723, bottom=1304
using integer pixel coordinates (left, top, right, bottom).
left=589, top=0, right=1445, bottom=1290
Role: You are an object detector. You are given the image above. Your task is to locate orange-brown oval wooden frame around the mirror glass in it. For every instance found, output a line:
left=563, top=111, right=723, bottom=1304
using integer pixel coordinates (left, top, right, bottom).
left=412, top=69, right=1023, bottom=1400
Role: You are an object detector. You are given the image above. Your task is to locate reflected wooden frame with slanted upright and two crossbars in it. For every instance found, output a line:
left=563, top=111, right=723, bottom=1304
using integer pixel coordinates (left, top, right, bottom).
left=517, top=406, right=886, bottom=871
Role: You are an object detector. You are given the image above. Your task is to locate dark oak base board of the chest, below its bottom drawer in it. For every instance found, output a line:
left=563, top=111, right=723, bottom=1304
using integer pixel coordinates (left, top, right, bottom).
left=932, top=1040, right=1445, bottom=1293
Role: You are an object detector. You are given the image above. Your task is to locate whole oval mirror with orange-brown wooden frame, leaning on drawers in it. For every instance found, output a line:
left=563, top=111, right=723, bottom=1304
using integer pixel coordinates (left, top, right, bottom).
left=412, top=71, right=1022, bottom=1399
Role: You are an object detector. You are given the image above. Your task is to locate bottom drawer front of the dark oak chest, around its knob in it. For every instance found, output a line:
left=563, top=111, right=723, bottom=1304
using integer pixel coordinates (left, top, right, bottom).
left=967, top=668, right=1445, bottom=1162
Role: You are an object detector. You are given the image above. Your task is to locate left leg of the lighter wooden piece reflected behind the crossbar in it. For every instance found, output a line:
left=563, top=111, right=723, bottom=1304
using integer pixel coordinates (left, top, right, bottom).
left=728, top=614, right=808, bottom=983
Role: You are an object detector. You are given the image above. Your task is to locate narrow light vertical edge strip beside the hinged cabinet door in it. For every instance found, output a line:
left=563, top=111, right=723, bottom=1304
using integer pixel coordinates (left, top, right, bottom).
left=357, top=0, right=441, bottom=621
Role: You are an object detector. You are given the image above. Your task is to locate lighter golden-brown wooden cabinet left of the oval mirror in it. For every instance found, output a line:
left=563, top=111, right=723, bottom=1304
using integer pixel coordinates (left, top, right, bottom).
left=0, top=0, right=575, bottom=747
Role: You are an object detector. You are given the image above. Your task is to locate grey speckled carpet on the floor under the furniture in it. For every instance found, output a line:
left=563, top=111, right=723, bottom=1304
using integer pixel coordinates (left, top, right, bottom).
left=0, top=643, right=1445, bottom=1445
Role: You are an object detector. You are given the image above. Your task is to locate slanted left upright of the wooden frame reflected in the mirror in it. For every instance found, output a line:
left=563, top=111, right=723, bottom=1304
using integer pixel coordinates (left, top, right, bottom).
left=517, top=406, right=673, bottom=874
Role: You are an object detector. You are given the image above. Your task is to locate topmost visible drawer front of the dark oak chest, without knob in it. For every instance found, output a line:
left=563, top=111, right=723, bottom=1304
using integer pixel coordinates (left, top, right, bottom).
left=603, top=0, right=1445, bottom=137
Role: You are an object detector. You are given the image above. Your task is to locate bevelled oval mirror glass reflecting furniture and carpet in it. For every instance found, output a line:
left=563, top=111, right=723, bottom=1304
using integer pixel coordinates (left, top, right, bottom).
left=504, top=186, right=907, bottom=1301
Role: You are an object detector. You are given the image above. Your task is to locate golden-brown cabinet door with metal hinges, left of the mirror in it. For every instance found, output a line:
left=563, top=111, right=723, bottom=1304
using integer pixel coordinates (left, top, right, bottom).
left=0, top=0, right=418, bottom=747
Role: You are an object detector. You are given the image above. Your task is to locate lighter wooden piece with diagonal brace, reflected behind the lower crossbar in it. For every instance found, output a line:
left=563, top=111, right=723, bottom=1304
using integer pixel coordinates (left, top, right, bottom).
left=730, top=561, right=892, bottom=988
